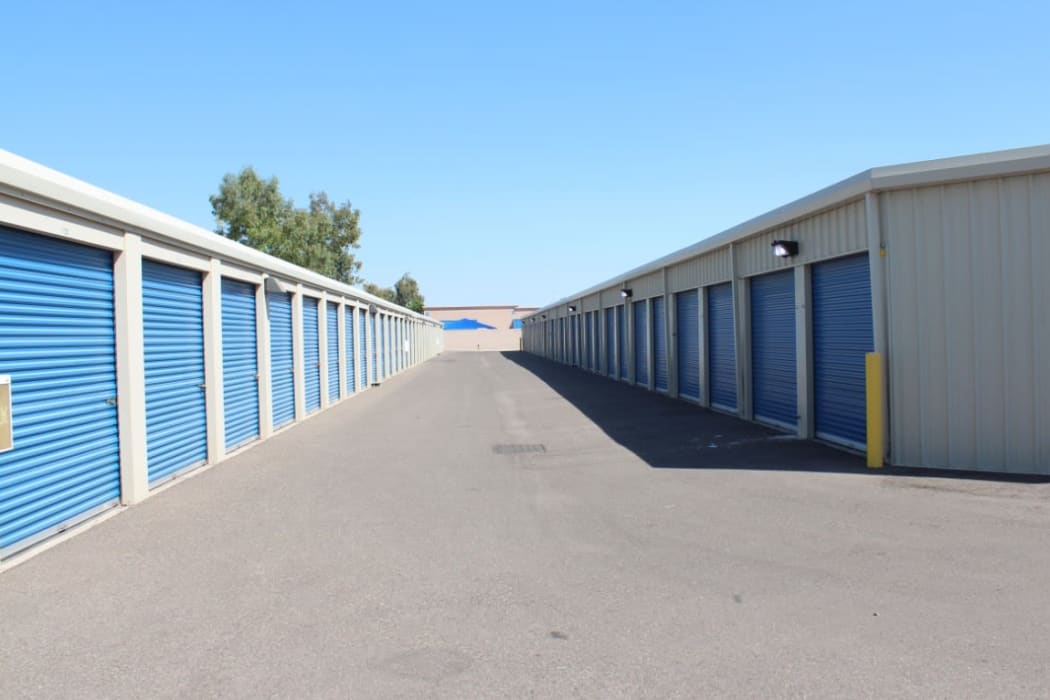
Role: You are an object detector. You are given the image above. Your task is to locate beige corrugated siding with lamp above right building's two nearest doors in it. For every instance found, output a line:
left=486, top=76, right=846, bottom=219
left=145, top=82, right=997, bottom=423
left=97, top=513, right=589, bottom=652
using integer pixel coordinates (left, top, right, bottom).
left=736, top=199, right=867, bottom=277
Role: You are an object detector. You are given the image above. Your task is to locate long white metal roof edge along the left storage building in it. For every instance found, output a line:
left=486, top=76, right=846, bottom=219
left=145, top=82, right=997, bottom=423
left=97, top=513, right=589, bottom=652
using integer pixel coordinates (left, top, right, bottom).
left=0, top=149, right=436, bottom=325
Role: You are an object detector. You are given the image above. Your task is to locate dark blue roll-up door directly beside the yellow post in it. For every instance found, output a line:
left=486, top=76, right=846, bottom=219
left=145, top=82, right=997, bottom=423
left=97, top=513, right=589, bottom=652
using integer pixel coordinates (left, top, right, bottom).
left=813, top=255, right=875, bottom=449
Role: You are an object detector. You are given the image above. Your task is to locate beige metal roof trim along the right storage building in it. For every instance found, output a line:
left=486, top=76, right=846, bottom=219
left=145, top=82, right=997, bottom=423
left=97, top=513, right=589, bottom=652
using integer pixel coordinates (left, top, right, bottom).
left=526, top=145, right=1050, bottom=318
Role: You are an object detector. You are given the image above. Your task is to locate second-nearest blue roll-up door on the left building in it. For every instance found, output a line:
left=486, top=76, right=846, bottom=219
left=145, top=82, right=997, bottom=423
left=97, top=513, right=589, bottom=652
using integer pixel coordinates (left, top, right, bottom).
left=142, top=260, right=208, bottom=485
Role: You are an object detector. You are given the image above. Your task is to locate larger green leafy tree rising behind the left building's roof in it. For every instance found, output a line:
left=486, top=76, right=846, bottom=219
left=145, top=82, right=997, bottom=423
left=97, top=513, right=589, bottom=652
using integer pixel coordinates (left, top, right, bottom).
left=209, top=166, right=361, bottom=284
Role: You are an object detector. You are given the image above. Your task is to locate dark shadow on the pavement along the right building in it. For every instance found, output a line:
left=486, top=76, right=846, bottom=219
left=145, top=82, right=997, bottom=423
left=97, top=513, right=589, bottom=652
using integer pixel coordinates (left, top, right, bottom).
left=502, top=352, right=1050, bottom=483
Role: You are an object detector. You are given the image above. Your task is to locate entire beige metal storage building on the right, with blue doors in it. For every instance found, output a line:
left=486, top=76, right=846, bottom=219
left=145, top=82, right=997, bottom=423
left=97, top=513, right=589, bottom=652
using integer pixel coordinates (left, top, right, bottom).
left=525, top=146, right=1050, bottom=474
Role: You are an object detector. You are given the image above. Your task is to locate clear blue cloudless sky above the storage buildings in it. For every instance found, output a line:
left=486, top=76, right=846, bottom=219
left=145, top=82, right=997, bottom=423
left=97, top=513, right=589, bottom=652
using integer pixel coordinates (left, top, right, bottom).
left=0, top=0, right=1050, bottom=305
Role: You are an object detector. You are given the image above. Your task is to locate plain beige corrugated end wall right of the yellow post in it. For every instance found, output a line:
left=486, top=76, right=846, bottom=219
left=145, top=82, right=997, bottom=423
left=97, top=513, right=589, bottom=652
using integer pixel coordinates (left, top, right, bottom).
left=880, top=174, right=1050, bottom=474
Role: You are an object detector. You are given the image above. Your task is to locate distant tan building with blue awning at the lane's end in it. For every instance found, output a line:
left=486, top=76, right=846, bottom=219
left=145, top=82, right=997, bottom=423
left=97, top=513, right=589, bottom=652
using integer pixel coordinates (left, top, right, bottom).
left=424, top=306, right=536, bottom=351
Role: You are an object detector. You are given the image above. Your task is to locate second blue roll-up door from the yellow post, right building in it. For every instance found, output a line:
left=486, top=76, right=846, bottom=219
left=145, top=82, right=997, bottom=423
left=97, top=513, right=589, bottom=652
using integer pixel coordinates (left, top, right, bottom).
left=751, top=270, right=798, bottom=428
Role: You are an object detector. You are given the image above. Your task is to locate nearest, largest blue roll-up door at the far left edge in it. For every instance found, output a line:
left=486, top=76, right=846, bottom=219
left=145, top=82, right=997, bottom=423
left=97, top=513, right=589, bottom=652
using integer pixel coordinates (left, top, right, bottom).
left=0, top=228, right=120, bottom=557
